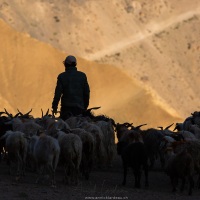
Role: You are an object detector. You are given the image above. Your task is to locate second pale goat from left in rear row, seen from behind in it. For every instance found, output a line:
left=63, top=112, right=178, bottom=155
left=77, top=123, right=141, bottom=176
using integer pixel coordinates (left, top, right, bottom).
left=33, top=133, right=60, bottom=187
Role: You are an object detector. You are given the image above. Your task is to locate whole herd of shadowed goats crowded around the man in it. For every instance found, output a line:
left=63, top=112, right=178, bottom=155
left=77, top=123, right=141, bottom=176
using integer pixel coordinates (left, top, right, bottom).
left=0, top=108, right=200, bottom=195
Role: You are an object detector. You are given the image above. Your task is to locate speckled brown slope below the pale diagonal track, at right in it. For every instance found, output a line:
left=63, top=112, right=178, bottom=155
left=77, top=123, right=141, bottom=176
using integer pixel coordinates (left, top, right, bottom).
left=96, top=13, right=200, bottom=117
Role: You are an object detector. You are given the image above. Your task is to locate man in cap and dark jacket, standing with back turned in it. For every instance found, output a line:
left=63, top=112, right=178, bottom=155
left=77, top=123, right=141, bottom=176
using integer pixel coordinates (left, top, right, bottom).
left=52, top=55, right=90, bottom=120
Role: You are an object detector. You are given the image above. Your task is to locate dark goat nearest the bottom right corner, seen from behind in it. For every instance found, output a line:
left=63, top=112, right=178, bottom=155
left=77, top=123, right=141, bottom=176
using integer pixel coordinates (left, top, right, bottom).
left=165, top=149, right=194, bottom=195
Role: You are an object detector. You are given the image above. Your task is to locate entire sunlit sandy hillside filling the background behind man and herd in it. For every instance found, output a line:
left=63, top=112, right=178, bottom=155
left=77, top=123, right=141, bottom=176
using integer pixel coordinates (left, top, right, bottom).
left=0, top=0, right=200, bottom=127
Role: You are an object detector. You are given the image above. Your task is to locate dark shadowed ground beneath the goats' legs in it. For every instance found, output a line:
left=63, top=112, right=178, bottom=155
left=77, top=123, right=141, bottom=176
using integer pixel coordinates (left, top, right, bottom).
left=0, top=152, right=200, bottom=200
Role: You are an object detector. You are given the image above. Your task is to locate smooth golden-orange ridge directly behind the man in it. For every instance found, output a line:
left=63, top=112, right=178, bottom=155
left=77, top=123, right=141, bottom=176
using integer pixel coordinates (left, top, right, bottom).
left=0, top=20, right=179, bottom=126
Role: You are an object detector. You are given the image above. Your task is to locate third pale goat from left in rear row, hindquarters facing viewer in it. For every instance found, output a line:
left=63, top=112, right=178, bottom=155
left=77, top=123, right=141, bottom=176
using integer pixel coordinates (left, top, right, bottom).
left=57, top=131, right=83, bottom=185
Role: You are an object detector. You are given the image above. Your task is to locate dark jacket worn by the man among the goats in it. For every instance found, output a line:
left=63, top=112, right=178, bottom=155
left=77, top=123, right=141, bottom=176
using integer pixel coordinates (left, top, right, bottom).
left=52, top=67, right=90, bottom=110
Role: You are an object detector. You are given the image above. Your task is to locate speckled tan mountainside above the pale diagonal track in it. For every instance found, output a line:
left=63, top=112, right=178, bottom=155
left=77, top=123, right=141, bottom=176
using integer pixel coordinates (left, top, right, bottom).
left=0, top=0, right=200, bottom=57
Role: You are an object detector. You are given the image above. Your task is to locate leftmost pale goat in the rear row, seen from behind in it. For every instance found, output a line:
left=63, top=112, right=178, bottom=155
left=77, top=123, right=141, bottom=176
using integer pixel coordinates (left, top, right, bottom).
left=1, top=131, right=28, bottom=180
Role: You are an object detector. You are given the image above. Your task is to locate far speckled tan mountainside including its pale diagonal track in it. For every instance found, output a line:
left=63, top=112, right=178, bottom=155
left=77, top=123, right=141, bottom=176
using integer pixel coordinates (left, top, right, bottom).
left=0, top=0, right=200, bottom=118
